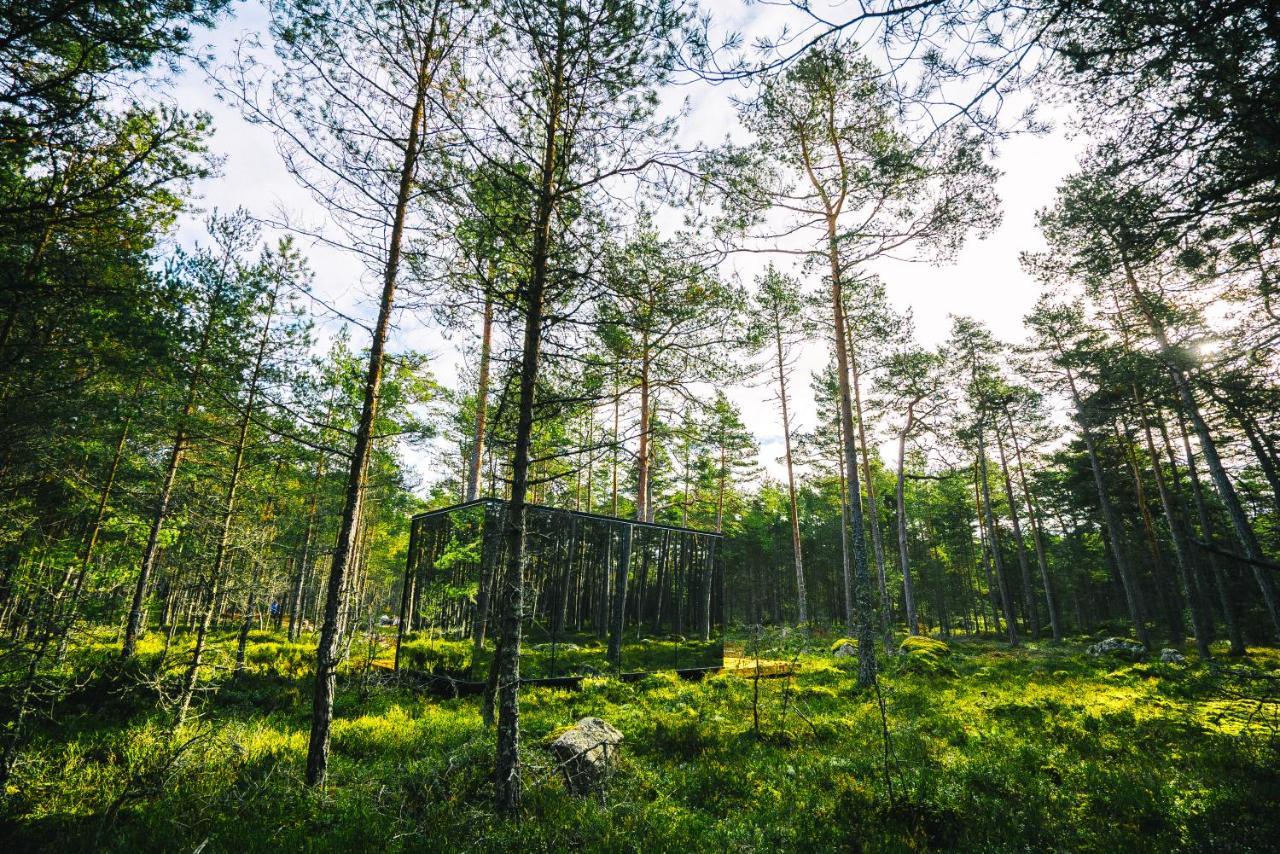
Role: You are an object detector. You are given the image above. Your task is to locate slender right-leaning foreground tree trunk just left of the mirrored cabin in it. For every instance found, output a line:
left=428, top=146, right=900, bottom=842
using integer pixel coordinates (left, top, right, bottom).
left=306, top=40, right=436, bottom=786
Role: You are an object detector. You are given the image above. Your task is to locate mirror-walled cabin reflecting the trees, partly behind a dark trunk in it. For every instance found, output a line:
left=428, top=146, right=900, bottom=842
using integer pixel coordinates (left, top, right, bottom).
left=397, top=499, right=724, bottom=680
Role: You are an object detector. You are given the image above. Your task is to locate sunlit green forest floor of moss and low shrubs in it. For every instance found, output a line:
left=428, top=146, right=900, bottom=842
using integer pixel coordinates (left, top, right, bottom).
left=0, top=632, right=1280, bottom=853
